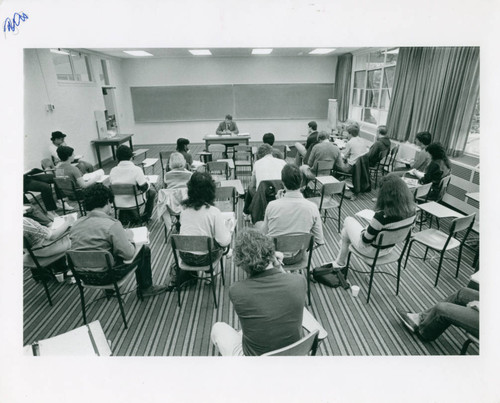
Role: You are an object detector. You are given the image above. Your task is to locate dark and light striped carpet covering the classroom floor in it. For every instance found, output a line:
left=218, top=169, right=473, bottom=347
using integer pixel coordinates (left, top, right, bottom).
left=23, top=144, right=478, bottom=356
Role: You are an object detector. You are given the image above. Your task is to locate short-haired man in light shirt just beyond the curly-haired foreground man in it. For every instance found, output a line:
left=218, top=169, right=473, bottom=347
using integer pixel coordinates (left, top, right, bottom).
left=256, top=164, right=325, bottom=264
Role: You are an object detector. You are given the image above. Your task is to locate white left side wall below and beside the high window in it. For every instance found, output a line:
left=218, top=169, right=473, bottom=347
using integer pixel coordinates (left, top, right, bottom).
left=24, top=49, right=113, bottom=169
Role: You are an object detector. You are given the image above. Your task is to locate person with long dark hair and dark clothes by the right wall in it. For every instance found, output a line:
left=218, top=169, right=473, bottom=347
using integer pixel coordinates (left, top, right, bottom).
left=410, top=143, right=451, bottom=201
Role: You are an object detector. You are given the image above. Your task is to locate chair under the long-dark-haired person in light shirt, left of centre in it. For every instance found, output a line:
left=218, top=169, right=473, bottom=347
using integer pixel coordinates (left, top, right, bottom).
left=171, top=235, right=224, bottom=308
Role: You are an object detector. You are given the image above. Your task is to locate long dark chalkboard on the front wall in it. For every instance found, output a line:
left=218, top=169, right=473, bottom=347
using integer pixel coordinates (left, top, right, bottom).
left=130, top=84, right=333, bottom=122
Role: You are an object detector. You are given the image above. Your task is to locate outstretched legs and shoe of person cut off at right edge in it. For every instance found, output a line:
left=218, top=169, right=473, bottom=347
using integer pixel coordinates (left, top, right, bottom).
left=396, top=288, right=479, bottom=341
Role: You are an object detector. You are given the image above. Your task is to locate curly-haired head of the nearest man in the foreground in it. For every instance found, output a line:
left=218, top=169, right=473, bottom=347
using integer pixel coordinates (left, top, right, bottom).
left=234, top=229, right=275, bottom=276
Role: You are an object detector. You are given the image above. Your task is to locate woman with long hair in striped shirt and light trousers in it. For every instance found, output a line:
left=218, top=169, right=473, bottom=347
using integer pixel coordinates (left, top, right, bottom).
left=332, top=174, right=415, bottom=268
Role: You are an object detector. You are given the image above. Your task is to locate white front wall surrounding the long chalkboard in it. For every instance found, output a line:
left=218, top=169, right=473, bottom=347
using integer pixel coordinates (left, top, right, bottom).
left=121, top=57, right=337, bottom=144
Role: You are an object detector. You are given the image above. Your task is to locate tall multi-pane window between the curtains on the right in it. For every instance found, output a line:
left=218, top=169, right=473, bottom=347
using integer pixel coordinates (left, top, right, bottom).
left=350, top=48, right=398, bottom=125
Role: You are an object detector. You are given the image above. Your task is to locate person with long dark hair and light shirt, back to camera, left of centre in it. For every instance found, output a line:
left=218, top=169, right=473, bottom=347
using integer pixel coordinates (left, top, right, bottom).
left=180, top=172, right=231, bottom=266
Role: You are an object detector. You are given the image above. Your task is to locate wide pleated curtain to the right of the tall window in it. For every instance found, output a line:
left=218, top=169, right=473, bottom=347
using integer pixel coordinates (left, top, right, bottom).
left=387, top=47, right=479, bottom=156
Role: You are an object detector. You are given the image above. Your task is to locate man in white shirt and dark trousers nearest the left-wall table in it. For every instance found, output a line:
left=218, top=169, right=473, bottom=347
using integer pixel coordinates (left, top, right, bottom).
left=109, top=145, right=156, bottom=221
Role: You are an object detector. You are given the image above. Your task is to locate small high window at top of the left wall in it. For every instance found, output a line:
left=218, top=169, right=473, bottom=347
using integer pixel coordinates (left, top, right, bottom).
left=50, top=49, right=92, bottom=83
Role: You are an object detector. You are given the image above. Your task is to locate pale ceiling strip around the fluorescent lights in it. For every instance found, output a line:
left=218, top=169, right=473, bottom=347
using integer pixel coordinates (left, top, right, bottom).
left=88, top=47, right=360, bottom=59
